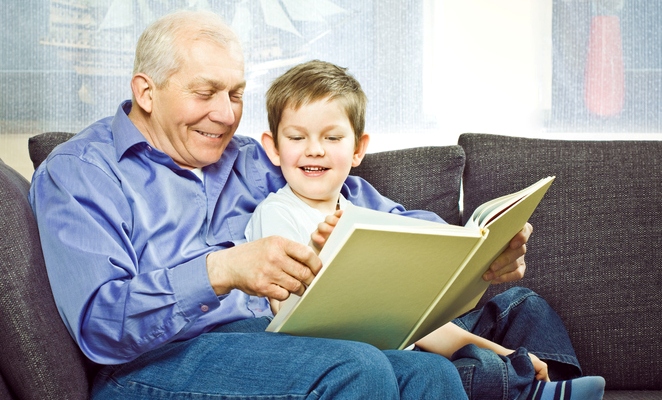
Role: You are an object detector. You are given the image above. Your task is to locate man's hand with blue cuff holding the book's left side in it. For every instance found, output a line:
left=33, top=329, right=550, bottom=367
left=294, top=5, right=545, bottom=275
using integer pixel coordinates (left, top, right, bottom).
left=207, top=236, right=322, bottom=300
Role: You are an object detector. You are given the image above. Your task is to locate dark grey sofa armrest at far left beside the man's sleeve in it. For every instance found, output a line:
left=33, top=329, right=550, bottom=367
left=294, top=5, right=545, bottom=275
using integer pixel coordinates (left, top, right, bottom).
left=0, top=161, right=89, bottom=399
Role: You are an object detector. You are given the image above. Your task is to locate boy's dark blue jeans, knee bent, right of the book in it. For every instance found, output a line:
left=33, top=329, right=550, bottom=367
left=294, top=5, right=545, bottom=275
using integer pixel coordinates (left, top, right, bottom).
left=451, top=287, right=581, bottom=400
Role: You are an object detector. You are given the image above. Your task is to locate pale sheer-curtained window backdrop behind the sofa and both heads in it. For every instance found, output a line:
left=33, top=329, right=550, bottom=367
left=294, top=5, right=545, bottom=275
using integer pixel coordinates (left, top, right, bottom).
left=0, top=0, right=662, bottom=178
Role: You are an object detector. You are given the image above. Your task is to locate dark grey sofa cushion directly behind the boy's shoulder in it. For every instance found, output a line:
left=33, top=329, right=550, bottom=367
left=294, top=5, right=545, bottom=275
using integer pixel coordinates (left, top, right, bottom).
left=352, top=146, right=464, bottom=224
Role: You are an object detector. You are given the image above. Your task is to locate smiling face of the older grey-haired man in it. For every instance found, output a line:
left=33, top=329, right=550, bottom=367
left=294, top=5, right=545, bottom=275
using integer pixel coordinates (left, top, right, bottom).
left=147, top=40, right=245, bottom=168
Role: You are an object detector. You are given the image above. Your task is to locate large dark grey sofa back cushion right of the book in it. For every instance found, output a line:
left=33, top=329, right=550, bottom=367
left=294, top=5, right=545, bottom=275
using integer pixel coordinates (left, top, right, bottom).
left=459, top=134, right=662, bottom=390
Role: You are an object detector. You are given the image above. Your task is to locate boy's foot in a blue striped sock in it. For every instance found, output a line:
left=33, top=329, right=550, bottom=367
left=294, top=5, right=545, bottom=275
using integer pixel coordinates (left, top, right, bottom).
left=527, top=376, right=605, bottom=400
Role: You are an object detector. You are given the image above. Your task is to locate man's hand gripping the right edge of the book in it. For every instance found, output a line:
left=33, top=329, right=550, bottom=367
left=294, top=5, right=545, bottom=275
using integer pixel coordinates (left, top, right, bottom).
left=483, top=222, right=533, bottom=283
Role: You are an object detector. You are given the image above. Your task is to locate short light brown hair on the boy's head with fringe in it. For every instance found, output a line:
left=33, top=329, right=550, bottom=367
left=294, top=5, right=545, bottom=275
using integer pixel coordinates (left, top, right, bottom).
left=267, top=60, right=368, bottom=146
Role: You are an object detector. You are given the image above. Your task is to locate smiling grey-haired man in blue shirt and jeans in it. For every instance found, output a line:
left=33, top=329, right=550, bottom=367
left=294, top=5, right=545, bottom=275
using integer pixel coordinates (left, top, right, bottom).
left=30, top=12, right=560, bottom=399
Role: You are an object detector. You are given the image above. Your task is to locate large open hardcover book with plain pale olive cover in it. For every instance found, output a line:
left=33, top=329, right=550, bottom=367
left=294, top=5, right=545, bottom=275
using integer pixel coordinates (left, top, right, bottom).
left=267, top=177, right=554, bottom=349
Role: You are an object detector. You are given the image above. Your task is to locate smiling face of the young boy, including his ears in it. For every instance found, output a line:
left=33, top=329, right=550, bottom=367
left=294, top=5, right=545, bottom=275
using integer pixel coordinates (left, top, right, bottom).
left=262, top=99, right=369, bottom=213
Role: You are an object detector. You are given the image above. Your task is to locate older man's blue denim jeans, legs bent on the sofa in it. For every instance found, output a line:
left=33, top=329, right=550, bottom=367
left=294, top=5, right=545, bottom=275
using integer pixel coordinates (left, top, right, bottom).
left=93, top=318, right=464, bottom=399
